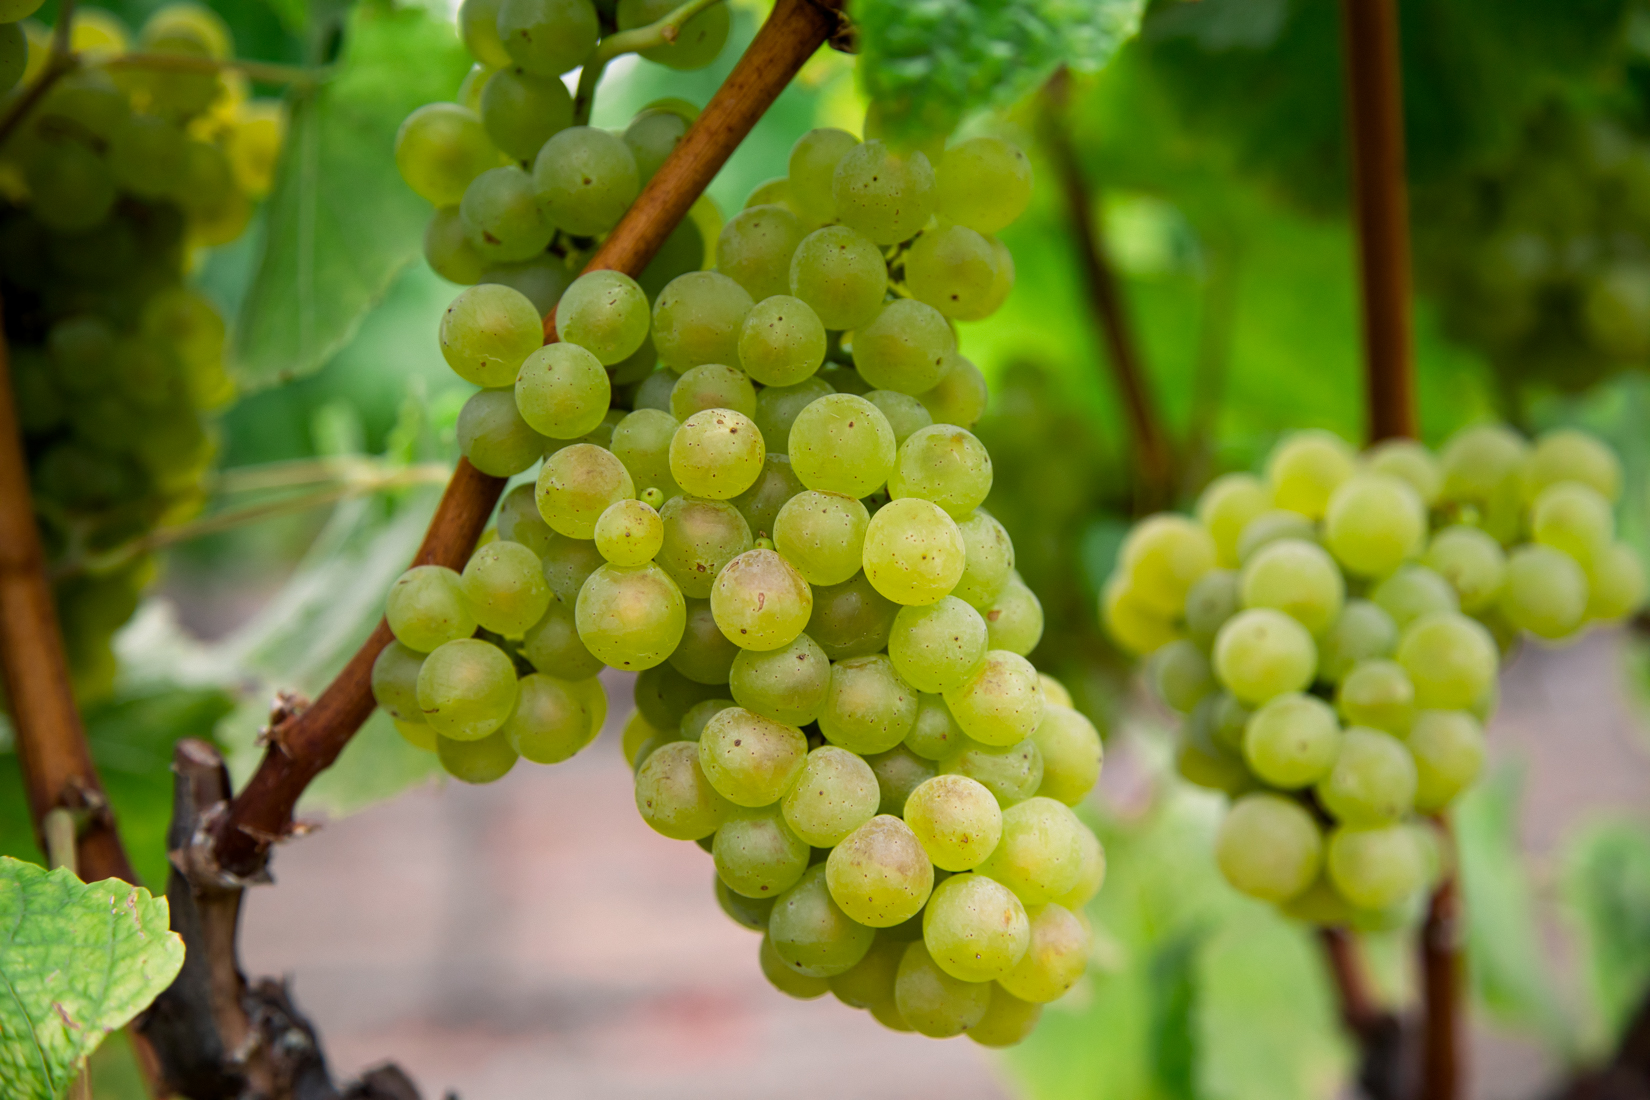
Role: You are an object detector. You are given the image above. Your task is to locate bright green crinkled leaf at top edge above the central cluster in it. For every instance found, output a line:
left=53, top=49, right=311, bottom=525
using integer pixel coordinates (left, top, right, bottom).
left=853, top=0, right=1145, bottom=135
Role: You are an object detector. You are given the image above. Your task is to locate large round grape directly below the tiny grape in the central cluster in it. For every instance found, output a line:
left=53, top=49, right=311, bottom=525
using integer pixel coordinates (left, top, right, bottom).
left=574, top=562, right=688, bottom=671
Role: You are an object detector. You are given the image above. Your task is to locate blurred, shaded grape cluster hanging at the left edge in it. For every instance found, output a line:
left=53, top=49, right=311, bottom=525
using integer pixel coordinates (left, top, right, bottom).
left=0, top=0, right=284, bottom=694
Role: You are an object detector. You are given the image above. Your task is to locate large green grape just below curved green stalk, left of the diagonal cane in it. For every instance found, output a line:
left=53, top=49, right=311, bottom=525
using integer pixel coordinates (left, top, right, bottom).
left=534, top=124, right=642, bottom=237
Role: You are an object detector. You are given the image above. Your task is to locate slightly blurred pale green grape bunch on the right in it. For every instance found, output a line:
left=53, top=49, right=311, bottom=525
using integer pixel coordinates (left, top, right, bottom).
left=1102, top=425, right=1645, bottom=925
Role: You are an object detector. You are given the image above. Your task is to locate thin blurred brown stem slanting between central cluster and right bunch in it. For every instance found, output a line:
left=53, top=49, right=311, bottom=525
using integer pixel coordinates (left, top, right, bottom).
left=1041, top=69, right=1175, bottom=513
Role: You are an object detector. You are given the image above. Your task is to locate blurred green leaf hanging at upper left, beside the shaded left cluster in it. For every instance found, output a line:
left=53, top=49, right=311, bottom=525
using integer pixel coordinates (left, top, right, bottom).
left=233, top=0, right=470, bottom=391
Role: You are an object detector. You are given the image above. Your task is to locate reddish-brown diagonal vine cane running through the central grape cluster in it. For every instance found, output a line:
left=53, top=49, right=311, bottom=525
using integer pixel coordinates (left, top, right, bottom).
left=213, top=0, right=840, bottom=879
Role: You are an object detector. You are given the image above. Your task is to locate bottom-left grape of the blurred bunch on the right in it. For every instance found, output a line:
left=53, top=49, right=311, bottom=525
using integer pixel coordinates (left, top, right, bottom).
left=1214, top=793, right=1323, bottom=904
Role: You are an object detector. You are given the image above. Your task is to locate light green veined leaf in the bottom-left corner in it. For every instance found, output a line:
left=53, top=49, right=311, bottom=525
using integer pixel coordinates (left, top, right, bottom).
left=0, top=858, right=183, bottom=1100
